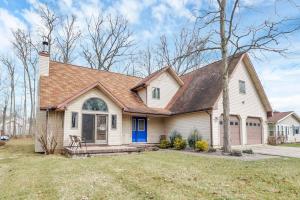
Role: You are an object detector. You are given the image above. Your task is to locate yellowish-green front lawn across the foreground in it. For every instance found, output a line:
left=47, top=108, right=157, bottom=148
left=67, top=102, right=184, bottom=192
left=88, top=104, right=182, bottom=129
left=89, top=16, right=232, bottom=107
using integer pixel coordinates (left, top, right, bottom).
left=0, top=139, right=300, bottom=199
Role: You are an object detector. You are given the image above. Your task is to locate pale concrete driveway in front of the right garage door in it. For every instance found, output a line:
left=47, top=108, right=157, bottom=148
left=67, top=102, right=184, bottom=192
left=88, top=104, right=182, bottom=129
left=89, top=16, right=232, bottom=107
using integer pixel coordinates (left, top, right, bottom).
left=251, top=145, right=300, bottom=158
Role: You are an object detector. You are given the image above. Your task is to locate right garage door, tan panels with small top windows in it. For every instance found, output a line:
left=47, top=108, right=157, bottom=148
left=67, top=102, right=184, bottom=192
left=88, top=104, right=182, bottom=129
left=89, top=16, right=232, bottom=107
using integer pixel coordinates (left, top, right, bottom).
left=246, top=117, right=262, bottom=144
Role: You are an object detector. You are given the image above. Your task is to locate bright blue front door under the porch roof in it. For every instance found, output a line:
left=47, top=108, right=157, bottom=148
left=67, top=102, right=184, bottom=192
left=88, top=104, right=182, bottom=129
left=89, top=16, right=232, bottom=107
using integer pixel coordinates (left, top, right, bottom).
left=132, top=117, right=147, bottom=142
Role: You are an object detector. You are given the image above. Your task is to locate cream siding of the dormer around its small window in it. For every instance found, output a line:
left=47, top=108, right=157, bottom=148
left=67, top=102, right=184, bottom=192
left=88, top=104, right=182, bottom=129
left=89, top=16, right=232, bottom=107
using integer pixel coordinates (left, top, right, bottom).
left=147, top=72, right=180, bottom=108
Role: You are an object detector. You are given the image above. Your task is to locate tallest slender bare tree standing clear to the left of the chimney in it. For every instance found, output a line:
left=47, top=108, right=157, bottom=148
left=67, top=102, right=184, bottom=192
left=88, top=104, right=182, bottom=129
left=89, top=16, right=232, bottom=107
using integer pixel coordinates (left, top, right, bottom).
left=12, top=30, right=38, bottom=134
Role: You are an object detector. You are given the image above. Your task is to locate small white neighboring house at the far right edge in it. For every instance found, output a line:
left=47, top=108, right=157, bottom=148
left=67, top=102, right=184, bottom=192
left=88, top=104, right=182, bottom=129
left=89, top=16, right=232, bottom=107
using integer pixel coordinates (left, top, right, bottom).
left=268, top=111, right=300, bottom=142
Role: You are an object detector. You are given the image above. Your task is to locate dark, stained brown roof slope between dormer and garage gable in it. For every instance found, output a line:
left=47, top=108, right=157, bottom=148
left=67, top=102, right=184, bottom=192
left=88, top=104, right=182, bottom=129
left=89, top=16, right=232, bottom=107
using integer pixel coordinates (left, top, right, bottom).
left=167, top=54, right=242, bottom=113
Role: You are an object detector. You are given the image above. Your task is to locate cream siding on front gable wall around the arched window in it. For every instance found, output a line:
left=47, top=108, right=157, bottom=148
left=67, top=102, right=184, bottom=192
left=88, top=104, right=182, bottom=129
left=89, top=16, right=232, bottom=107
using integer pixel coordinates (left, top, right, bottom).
left=64, top=89, right=123, bottom=146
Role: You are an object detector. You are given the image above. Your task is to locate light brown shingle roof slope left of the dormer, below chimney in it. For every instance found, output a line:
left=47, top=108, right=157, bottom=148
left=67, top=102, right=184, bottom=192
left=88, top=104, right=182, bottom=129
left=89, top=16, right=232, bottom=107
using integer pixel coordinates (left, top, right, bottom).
left=40, top=61, right=169, bottom=114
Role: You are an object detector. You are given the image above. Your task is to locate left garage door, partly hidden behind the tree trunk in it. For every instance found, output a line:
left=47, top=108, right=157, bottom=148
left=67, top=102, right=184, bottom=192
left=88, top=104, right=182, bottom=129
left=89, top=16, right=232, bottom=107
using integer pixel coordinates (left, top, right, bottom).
left=220, top=115, right=241, bottom=146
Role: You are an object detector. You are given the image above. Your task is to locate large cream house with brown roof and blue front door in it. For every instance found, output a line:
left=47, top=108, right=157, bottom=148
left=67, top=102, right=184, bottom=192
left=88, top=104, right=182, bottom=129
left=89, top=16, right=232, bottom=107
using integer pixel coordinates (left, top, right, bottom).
left=36, top=52, right=272, bottom=151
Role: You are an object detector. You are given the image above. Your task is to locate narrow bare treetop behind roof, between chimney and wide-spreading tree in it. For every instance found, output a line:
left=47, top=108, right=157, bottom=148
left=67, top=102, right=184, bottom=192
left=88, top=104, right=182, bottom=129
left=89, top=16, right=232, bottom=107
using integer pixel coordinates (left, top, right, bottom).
left=57, top=15, right=81, bottom=63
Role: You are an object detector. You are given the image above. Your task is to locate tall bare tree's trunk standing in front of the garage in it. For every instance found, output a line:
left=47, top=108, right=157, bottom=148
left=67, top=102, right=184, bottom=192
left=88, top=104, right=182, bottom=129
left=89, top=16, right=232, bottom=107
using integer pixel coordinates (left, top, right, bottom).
left=220, top=0, right=231, bottom=153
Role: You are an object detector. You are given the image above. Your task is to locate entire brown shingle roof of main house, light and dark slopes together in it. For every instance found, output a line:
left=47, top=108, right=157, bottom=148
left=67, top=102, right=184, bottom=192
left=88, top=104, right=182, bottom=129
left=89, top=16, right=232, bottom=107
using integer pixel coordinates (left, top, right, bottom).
left=40, top=54, right=268, bottom=115
